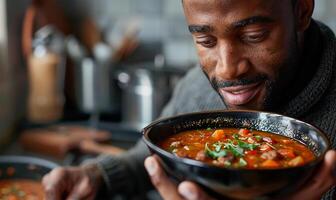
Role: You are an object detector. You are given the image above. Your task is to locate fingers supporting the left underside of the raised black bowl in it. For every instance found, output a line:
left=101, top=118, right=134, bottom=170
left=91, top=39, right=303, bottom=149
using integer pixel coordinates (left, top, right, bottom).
left=145, top=155, right=212, bottom=200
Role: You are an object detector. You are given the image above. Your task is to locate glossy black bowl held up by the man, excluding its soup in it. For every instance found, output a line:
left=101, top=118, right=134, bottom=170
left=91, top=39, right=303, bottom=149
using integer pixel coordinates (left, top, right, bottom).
left=143, top=111, right=329, bottom=199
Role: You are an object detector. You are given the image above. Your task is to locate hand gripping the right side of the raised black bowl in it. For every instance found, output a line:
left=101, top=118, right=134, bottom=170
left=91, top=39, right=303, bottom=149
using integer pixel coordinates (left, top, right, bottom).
left=291, top=150, right=336, bottom=200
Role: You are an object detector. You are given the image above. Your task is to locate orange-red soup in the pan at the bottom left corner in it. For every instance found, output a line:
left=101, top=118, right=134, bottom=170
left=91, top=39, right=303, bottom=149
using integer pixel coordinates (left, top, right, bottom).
left=0, top=179, right=45, bottom=200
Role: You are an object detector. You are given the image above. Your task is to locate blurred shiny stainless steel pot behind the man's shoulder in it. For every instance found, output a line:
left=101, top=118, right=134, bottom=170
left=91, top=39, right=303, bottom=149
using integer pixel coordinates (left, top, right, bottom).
left=117, top=63, right=183, bottom=130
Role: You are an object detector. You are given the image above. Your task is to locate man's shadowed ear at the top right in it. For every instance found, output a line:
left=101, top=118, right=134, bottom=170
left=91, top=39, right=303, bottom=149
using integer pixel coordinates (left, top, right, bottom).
left=294, top=0, right=315, bottom=32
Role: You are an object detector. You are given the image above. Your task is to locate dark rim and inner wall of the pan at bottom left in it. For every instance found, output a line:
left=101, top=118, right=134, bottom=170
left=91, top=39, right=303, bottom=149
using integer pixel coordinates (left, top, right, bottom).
left=0, top=156, right=58, bottom=181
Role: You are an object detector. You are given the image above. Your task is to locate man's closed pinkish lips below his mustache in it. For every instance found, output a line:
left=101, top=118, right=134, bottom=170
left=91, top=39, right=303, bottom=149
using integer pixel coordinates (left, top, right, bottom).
left=219, top=81, right=264, bottom=106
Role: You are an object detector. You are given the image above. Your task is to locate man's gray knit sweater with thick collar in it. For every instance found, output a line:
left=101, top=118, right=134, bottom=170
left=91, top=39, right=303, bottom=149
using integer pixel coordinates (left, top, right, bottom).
left=97, top=22, right=336, bottom=199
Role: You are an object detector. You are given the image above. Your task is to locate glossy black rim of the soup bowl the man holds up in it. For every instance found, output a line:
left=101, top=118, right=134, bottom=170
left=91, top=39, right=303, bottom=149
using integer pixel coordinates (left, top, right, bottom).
left=142, top=110, right=330, bottom=172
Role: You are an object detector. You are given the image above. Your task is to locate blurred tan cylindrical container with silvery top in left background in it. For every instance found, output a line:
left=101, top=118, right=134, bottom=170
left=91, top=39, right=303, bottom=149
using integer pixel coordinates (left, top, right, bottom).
left=27, top=26, right=65, bottom=123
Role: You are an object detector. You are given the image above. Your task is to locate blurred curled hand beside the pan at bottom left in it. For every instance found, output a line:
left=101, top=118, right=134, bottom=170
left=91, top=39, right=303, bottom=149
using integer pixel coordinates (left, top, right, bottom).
left=42, top=164, right=102, bottom=200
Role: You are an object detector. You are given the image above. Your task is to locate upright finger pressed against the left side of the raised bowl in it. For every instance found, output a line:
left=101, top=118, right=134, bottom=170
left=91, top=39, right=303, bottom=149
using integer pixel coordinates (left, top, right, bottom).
left=145, top=156, right=182, bottom=200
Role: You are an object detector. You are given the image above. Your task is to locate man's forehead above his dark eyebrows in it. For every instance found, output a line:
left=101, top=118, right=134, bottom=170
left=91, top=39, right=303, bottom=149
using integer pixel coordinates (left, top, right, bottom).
left=184, top=0, right=290, bottom=24
